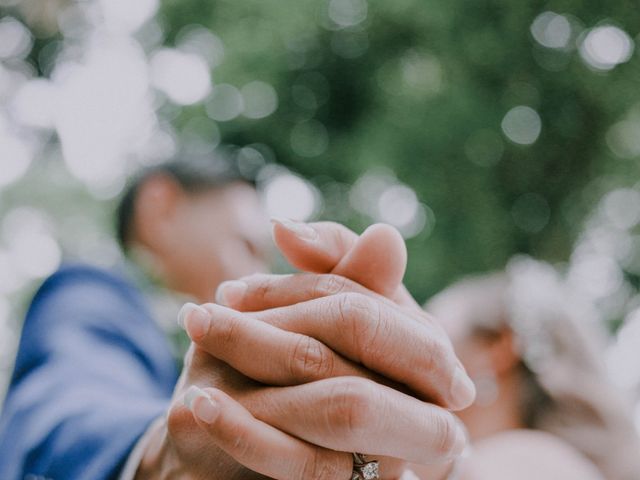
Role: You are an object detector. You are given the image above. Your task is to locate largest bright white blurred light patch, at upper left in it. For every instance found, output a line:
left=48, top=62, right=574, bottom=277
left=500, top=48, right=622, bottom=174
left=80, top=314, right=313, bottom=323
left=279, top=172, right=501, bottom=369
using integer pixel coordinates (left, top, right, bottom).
left=53, top=37, right=155, bottom=190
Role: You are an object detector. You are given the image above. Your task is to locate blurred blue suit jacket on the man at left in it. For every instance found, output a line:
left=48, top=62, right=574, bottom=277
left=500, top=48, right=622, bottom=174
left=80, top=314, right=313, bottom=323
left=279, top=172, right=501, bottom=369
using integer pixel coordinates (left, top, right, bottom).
left=0, top=266, right=177, bottom=480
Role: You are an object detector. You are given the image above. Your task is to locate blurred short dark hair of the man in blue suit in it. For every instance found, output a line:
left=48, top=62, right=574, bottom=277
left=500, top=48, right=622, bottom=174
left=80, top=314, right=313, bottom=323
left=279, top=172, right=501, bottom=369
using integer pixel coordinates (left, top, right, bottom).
left=115, top=158, right=253, bottom=252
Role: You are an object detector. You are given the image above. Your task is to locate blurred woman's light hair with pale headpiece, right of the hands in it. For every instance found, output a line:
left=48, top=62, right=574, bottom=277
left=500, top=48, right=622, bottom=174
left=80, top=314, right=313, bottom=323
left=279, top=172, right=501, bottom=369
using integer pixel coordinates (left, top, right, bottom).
left=427, top=257, right=640, bottom=480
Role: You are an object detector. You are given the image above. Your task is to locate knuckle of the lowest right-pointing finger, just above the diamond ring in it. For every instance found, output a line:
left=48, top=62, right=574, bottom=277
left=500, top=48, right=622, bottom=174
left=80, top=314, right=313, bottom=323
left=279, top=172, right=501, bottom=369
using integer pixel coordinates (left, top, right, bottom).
left=327, top=377, right=376, bottom=438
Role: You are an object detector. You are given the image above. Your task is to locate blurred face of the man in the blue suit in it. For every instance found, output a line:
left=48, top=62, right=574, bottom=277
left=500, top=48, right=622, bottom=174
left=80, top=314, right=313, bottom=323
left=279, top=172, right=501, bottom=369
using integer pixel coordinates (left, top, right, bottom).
left=161, top=182, right=271, bottom=302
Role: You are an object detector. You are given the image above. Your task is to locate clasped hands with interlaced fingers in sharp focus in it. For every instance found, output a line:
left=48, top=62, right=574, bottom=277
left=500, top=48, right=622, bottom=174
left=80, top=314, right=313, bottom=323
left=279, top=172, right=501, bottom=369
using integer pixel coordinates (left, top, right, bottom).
left=138, top=223, right=474, bottom=480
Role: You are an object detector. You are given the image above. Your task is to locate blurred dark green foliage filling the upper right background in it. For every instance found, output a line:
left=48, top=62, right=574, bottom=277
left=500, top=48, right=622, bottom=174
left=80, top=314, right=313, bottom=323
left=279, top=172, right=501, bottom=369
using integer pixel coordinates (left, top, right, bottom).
left=154, top=0, right=640, bottom=299
